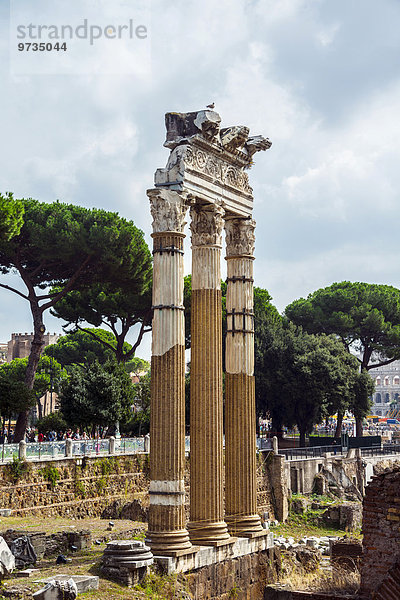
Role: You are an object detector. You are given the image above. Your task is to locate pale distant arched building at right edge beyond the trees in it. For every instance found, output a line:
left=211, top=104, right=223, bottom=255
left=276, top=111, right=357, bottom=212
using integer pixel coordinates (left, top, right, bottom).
left=369, top=360, right=400, bottom=417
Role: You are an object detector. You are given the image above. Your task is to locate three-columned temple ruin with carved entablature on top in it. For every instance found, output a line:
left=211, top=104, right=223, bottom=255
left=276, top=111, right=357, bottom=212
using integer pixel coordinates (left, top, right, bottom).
left=147, top=110, right=271, bottom=555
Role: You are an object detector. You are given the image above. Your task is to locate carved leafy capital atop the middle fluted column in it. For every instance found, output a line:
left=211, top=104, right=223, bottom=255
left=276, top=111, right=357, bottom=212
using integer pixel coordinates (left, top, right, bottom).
left=190, top=204, right=225, bottom=246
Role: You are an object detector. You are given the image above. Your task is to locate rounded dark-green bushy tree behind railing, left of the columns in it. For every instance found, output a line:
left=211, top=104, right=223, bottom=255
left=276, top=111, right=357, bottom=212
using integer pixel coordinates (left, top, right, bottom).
left=60, top=362, right=135, bottom=429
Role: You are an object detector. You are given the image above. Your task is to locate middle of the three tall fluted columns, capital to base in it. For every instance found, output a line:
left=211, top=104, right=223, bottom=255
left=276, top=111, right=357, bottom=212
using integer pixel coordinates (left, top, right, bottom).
left=188, top=205, right=230, bottom=545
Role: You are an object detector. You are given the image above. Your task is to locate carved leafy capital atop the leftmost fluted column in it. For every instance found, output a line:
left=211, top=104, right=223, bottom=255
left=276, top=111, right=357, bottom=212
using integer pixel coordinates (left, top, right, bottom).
left=147, top=188, right=187, bottom=233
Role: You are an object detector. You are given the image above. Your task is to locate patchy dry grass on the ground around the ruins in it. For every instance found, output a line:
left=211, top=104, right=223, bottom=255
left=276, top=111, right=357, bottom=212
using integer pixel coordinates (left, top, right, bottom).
left=0, top=506, right=359, bottom=600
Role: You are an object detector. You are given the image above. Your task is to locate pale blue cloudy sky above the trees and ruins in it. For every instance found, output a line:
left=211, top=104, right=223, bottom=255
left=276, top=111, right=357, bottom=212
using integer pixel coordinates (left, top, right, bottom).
left=0, top=0, right=400, bottom=356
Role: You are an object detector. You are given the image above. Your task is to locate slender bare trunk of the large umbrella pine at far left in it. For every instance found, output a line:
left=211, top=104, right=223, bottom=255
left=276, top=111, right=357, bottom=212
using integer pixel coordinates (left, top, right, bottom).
left=14, top=299, right=46, bottom=443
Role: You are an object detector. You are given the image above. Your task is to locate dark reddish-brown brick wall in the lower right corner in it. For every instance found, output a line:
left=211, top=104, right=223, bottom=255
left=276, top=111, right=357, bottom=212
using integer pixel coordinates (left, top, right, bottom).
left=361, top=467, right=400, bottom=599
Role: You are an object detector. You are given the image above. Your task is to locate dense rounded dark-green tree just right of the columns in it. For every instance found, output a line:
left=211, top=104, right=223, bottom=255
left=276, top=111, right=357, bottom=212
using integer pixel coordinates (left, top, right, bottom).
left=256, top=323, right=359, bottom=445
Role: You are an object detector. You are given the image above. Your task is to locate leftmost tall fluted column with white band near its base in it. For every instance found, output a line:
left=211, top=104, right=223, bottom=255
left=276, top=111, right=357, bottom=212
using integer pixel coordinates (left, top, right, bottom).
left=147, top=189, right=191, bottom=554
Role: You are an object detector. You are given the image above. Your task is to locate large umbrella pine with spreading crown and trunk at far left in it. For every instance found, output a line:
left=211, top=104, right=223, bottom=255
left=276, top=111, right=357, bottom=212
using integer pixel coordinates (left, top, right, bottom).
left=0, top=195, right=152, bottom=441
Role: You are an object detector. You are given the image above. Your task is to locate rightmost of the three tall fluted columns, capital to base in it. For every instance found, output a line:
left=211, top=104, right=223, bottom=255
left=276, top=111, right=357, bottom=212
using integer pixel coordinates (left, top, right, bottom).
left=225, top=218, right=263, bottom=537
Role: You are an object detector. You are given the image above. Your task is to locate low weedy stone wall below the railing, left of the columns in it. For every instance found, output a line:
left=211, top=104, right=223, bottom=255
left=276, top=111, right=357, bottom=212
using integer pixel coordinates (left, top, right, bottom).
left=0, top=454, right=148, bottom=518
